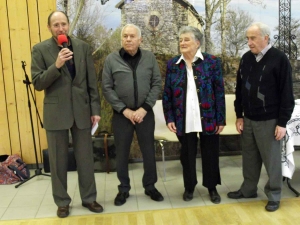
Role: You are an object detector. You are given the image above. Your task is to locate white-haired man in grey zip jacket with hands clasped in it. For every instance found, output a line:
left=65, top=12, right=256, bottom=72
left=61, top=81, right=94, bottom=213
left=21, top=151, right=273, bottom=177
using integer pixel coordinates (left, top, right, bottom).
left=102, top=24, right=163, bottom=206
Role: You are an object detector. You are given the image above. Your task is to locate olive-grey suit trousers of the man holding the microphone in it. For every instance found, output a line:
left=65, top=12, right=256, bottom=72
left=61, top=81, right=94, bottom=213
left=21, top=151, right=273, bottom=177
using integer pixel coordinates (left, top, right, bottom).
left=46, top=123, right=97, bottom=206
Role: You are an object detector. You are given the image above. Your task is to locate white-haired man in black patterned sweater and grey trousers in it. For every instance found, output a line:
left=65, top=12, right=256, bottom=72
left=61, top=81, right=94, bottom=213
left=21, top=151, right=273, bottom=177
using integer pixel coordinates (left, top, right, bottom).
left=227, top=22, right=295, bottom=212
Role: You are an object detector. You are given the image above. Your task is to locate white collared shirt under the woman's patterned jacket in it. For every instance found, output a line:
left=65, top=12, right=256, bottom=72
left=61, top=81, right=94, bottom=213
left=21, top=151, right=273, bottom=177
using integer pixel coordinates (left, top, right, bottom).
left=176, top=49, right=203, bottom=133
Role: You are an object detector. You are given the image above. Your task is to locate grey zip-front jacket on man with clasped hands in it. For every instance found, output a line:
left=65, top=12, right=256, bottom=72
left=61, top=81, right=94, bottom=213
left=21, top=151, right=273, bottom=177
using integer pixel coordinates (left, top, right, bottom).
left=102, top=49, right=161, bottom=112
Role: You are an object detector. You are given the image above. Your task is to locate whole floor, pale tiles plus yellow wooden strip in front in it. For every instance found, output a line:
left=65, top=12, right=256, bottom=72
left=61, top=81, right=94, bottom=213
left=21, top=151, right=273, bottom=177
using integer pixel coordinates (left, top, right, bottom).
left=0, top=151, right=300, bottom=225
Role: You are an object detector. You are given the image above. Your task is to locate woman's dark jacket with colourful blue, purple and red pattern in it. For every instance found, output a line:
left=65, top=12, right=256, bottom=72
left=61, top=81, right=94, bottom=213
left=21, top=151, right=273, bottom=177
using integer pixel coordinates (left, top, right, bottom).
left=163, top=53, right=225, bottom=136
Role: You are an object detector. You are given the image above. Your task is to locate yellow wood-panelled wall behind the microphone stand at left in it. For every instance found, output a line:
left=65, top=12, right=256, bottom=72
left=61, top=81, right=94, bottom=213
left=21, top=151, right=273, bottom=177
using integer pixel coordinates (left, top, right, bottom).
left=0, top=0, right=56, bottom=164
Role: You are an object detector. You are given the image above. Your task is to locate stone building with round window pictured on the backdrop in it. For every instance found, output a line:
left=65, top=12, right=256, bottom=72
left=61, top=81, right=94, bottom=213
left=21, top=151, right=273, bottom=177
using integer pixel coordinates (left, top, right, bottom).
left=116, top=0, right=204, bottom=55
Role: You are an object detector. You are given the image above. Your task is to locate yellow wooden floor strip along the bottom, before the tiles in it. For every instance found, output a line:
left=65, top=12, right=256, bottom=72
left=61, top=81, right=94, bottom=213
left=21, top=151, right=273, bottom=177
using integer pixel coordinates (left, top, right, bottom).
left=0, top=197, right=300, bottom=225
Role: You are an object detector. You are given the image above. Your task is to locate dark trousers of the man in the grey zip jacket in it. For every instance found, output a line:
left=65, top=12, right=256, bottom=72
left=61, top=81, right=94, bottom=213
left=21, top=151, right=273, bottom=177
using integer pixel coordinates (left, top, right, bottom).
left=112, top=111, right=157, bottom=192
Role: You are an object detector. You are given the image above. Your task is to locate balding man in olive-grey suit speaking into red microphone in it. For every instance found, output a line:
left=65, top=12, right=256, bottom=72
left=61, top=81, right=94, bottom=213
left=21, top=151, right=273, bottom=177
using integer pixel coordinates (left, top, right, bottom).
left=31, top=11, right=103, bottom=218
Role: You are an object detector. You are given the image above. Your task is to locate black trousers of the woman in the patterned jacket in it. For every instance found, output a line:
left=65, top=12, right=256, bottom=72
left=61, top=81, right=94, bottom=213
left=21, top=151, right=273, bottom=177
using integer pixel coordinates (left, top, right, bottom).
left=178, top=132, right=221, bottom=191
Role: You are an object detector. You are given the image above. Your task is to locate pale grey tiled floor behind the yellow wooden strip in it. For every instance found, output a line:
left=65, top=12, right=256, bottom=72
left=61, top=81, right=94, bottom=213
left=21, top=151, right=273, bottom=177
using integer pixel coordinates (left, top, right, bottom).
left=0, top=151, right=300, bottom=221
